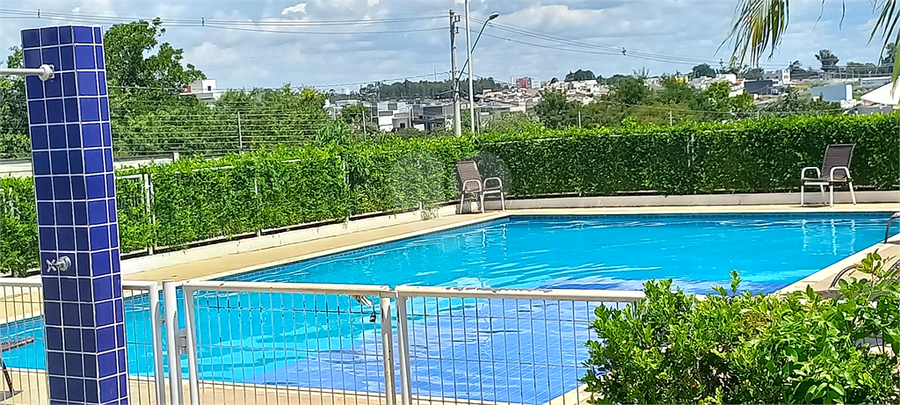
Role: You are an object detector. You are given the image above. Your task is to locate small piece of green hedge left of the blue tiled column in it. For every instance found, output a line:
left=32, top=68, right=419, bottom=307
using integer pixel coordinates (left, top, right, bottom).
left=0, top=177, right=38, bottom=276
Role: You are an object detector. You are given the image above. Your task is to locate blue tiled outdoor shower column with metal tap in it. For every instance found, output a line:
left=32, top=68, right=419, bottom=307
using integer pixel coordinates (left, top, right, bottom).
left=22, top=26, right=128, bottom=404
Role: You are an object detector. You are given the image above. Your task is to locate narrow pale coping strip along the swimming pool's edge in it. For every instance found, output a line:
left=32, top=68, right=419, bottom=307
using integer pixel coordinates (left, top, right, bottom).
left=183, top=206, right=900, bottom=294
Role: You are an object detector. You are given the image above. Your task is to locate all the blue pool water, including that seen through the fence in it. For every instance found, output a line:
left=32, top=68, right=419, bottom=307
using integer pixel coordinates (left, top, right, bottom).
left=0, top=213, right=889, bottom=403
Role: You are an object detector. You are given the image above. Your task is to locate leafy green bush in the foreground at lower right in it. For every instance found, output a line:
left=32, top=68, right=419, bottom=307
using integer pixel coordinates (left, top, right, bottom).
left=583, top=258, right=900, bottom=403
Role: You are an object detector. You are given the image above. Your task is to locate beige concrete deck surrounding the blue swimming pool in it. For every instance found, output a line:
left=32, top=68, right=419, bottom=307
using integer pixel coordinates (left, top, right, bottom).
left=123, top=203, right=900, bottom=291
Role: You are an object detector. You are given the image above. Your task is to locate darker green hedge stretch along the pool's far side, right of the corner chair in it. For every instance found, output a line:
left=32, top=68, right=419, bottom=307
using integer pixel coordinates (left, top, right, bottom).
left=479, top=115, right=898, bottom=196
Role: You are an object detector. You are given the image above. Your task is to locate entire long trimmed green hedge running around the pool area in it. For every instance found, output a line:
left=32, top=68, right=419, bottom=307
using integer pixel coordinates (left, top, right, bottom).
left=0, top=115, right=898, bottom=274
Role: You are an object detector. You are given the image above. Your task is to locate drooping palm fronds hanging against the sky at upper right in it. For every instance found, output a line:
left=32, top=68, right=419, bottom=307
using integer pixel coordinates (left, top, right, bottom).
left=723, top=0, right=900, bottom=80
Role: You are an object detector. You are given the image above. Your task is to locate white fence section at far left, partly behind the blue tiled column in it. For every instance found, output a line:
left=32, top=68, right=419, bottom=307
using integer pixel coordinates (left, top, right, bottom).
left=0, top=278, right=167, bottom=405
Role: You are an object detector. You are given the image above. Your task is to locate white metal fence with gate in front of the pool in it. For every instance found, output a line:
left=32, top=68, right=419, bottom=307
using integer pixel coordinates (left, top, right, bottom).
left=0, top=280, right=643, bottom=405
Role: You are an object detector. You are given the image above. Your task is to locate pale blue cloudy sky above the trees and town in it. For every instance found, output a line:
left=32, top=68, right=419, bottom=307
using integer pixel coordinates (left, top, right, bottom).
left=0, top=0, right=882, bottom=91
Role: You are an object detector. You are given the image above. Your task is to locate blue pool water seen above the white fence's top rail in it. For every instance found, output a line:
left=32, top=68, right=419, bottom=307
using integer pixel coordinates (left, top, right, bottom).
left=221, top=213, right=889, bottom=294
